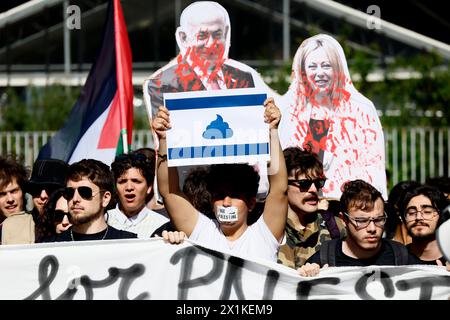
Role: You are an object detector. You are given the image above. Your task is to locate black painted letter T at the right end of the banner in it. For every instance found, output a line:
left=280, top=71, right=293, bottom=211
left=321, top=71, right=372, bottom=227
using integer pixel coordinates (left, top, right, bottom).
left=395, top=276, right=450, bottom=300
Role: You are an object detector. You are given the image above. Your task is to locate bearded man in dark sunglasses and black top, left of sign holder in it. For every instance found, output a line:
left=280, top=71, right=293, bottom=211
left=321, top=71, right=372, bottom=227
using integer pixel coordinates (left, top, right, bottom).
left=55, top=159, right=136, bottom=242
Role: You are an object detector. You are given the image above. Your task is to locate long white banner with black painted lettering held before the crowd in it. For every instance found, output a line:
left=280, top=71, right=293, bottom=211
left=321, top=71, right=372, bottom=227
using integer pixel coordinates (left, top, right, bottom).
left=0, top=239, right=450, bottom=300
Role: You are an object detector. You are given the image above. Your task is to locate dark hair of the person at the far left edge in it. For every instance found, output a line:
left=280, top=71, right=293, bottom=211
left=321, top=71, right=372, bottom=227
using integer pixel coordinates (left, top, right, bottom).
left=0, top=155, right=30, bottom=192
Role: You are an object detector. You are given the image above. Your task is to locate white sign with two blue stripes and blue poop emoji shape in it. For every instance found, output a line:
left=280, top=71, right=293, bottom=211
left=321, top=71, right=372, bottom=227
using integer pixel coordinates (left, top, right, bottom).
left=163, top=88, right=270, bottom=167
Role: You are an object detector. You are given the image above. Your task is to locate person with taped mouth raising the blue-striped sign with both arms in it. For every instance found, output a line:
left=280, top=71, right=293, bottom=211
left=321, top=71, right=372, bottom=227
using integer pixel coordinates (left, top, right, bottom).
left=152, top=98, right=287, bottom=262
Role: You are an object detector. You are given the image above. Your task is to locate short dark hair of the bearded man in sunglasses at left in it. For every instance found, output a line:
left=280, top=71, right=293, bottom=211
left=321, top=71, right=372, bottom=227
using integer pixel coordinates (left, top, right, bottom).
left=67, top=159, right=114, bottom=193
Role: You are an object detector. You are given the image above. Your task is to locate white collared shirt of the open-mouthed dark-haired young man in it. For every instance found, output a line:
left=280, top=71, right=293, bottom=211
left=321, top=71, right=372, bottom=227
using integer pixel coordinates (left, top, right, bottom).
left=105, top=205, right=169, bottom=239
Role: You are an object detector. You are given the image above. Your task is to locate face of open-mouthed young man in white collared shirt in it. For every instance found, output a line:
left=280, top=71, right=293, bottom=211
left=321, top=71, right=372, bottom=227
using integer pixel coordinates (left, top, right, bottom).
left=116, top=168, right=151, bottom=217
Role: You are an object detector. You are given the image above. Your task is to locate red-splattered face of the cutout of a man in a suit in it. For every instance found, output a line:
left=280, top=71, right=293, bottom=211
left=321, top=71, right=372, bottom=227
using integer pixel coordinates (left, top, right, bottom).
left=186, top=17, right=227, bottom=65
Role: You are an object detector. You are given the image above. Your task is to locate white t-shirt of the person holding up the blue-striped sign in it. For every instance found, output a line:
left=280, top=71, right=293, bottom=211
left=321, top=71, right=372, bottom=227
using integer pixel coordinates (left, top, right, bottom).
left=189, top=213, right=280, bottom=262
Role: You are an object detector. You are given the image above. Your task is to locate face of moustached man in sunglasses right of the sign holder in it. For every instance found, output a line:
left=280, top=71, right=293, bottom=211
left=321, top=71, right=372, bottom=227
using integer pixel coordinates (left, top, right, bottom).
left=288, top=172, right=320, bottom=214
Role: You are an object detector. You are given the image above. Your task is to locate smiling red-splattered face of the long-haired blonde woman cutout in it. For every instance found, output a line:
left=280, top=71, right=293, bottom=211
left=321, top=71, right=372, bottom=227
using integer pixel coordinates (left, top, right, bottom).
left=304, top=47, right=334, bottom=93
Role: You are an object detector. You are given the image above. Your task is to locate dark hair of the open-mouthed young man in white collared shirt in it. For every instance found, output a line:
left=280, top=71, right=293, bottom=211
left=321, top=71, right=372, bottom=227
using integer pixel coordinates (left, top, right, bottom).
left=111, top=152, right=155, bottom=186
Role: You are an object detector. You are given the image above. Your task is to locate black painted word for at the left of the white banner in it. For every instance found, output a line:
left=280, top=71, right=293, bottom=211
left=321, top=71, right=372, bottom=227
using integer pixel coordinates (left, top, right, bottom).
left=25, top=255, right=149, bottom=300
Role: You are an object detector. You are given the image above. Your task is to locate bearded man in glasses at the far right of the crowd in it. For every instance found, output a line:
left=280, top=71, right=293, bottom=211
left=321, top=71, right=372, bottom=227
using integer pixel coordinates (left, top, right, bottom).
left=401, top=185, right=447, bottom=266
